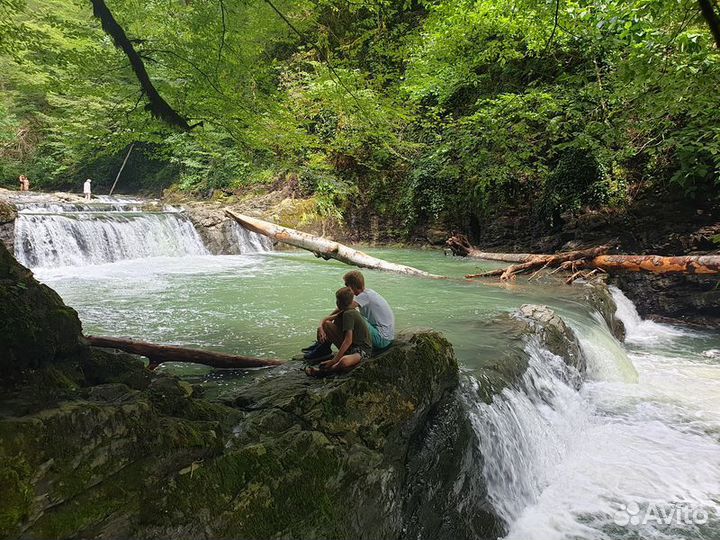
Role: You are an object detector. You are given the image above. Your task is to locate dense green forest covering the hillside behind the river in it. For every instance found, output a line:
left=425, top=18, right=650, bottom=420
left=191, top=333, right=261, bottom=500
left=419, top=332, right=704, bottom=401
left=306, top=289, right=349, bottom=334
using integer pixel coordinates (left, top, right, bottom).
left=0, top=0, right=720, bottom=235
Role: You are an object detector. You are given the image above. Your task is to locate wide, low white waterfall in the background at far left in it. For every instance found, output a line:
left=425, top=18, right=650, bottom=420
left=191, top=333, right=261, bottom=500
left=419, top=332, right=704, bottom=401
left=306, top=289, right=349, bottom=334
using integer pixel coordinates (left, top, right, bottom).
left=15, top=199, right=208, bottom=268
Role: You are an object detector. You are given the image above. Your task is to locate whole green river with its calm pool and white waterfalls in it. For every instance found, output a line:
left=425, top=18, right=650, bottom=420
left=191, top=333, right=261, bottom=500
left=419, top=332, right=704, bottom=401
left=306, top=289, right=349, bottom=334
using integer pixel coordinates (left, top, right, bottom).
left=16, top=200, right=720, bottom=540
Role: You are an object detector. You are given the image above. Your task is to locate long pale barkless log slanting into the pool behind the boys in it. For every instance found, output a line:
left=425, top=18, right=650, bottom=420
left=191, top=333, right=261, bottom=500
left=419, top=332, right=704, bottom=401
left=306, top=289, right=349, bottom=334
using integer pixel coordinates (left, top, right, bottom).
left=225, top=210, right=445, bottom=279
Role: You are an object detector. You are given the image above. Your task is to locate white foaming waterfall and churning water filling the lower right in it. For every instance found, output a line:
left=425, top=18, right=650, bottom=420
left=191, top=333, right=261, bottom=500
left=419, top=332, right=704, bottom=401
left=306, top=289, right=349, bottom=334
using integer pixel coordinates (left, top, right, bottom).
left=463, top=296, right=720, bottom=540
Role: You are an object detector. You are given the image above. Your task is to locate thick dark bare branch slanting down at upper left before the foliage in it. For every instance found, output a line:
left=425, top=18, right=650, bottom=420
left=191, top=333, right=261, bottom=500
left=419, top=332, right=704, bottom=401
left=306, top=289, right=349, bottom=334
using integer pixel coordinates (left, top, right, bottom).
left=90, top=0, right=191, bottom=131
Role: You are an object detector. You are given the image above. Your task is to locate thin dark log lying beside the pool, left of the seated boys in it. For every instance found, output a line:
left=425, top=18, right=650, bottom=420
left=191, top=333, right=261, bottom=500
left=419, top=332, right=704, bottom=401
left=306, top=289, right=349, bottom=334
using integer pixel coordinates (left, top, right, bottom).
left=86, top=336, right=284, bottom=369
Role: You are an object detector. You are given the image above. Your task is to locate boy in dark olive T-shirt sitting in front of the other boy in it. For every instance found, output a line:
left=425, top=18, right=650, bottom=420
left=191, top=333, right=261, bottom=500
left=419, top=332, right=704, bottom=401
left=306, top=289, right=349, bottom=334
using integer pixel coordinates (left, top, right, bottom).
left=305, top=287, right=372, bottom=377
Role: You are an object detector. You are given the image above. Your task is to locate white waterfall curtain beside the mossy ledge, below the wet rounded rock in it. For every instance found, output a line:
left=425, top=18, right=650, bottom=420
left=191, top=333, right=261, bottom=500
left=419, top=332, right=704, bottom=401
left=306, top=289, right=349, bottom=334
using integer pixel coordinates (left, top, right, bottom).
left=464, top=341, right=588, bottom=523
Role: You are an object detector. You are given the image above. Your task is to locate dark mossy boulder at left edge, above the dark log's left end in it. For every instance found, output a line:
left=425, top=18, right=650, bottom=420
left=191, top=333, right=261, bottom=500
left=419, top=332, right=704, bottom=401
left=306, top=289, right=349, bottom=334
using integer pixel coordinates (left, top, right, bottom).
left=0, top=243, right=88, bottom=378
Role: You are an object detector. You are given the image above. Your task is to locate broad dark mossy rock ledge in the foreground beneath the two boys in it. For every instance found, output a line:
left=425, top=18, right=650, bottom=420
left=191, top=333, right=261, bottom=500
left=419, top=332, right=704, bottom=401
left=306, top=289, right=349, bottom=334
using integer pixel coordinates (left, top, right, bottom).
left=0, top=332, right=472, bottom=539
